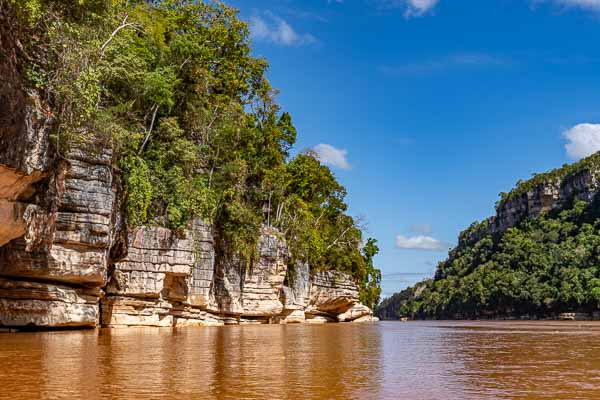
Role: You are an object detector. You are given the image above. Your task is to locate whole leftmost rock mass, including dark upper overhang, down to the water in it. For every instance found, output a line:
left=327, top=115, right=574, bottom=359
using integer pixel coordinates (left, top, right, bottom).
left=0, top=79, right=116, bottom=327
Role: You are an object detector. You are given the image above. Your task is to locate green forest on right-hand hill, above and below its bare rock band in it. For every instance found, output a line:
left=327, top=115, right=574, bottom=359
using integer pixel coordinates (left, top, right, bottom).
left=378, top=154, right=600, bottom=319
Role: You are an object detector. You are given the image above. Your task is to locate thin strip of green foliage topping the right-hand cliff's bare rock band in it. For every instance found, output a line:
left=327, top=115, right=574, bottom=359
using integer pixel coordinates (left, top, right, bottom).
left=496, top=153, right=600, bottom=210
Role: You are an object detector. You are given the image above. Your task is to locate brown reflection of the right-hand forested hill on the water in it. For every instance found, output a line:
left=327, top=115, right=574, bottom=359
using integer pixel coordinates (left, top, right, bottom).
left=434, top=323, right=600, bottom=399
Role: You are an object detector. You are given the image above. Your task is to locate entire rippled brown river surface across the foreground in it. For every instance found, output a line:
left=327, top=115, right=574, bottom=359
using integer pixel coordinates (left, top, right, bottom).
left=0, top=322, right=600, bottom=399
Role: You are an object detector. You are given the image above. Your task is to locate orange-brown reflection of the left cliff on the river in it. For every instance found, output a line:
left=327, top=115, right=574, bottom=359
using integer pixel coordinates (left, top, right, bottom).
left=0, top=325, right=383, bottom=399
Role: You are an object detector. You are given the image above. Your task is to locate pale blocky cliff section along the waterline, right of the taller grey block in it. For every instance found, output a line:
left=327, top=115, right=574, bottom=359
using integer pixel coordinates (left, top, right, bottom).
left=101, top=221, right=372, bottom=327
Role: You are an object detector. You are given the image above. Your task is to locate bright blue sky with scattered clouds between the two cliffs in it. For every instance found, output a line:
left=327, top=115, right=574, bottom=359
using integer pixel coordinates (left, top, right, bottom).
left=228, top=0, right=600, bottom=296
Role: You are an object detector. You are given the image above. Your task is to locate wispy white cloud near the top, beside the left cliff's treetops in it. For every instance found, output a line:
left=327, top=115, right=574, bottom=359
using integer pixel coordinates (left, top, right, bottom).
left=250, top=12, right=316, bottom=46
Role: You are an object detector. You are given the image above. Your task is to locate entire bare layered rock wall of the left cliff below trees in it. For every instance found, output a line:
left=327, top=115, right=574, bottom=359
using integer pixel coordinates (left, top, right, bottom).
left=0, top=93, right=374, bottom=328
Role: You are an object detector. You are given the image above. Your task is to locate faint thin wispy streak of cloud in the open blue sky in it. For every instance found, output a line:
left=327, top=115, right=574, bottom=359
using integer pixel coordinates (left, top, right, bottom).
left=379, top=53, right=511, bottom=76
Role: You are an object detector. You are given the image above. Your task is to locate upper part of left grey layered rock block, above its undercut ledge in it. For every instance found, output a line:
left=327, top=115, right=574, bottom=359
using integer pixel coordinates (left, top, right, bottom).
left=0, top=151, right=116, bottom=287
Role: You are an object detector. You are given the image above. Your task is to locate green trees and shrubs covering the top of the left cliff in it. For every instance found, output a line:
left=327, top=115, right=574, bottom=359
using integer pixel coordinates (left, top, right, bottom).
left=0, top=0, right=381, bottom=306
